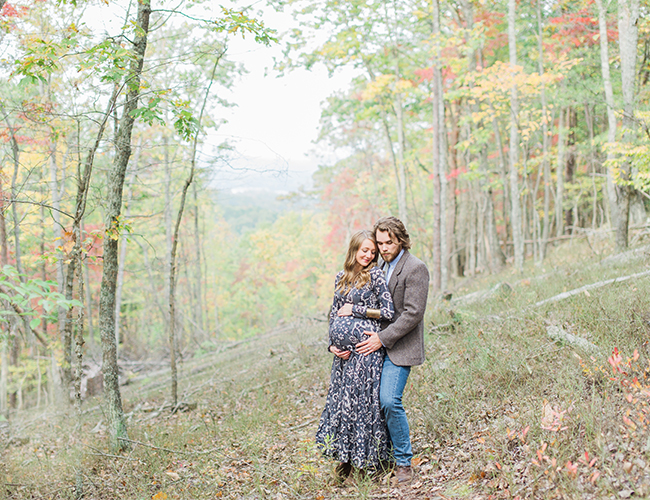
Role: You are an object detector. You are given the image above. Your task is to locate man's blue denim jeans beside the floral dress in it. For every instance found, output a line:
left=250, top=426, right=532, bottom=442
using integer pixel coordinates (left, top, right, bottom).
left=379, top=355, right=413, bottom=466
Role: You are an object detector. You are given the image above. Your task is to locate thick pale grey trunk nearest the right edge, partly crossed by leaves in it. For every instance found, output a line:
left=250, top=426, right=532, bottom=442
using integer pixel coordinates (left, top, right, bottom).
left=615, top=0, right=639, bottom=251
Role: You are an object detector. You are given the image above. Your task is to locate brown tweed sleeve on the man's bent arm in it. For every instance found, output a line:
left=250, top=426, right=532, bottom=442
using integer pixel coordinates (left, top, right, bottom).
left=378, top=262, right=429, bottom=349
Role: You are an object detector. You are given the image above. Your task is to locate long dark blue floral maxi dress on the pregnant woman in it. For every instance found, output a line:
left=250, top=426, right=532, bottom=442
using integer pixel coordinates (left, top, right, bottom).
left=316, top=267, right=394, bottom=469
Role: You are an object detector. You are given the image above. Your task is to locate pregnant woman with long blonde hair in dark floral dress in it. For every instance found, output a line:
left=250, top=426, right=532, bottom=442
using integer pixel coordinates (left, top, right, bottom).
left=316, top=231, right=394, bottom=479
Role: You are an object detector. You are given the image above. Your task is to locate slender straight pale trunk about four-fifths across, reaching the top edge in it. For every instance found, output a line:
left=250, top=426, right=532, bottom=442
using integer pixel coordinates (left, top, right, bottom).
left=508, top=0, right=524, bottom=272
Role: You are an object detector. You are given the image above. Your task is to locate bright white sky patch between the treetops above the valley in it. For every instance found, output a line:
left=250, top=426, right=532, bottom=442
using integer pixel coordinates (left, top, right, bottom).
left=214, top=5, right=352, bottom=189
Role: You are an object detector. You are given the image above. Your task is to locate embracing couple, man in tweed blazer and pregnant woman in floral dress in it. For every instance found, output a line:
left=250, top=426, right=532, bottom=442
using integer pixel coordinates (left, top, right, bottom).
left=316, top=217, right=429, bottom=482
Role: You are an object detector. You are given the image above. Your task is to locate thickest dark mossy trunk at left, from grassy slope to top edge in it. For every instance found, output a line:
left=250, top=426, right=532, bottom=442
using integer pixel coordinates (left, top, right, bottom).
left=99, top=0, right=151, bottom=450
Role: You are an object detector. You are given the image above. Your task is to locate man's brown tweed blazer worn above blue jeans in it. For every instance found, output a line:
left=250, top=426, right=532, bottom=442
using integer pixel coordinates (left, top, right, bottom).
left=379, top=250, right=429, bottom=366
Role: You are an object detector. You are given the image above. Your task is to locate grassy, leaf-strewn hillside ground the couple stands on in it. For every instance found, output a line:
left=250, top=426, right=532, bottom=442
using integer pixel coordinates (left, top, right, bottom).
left=0, top=236, right=650, bottom=500
